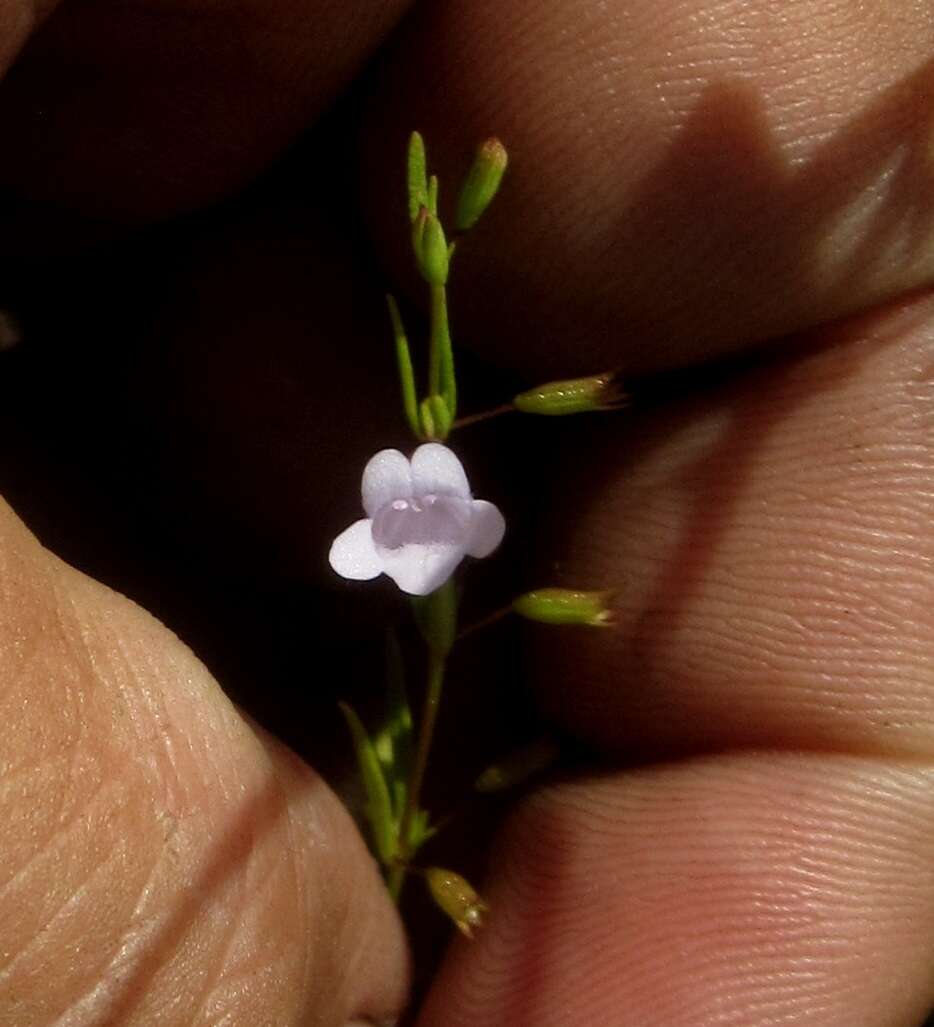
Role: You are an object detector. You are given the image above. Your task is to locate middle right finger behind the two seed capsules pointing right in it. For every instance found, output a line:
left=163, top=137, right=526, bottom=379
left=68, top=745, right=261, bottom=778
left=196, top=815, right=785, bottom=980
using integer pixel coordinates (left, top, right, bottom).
left=524, top=297, right=934, bottom=758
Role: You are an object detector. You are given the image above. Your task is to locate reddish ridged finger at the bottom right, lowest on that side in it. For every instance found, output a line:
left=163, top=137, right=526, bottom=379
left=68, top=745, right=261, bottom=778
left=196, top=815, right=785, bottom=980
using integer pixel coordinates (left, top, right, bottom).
left=419, top=751, right=934, bottom=1027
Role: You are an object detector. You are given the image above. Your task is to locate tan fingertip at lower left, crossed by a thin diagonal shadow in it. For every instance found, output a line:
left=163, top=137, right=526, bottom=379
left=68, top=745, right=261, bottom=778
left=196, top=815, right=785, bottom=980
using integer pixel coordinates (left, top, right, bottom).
left=0, top=492, right=407, bottom=1027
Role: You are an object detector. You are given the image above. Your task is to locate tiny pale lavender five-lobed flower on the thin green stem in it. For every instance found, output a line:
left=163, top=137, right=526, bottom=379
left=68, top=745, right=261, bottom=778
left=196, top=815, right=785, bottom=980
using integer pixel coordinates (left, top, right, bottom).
left=329, top=443, right=506, bottom=596
